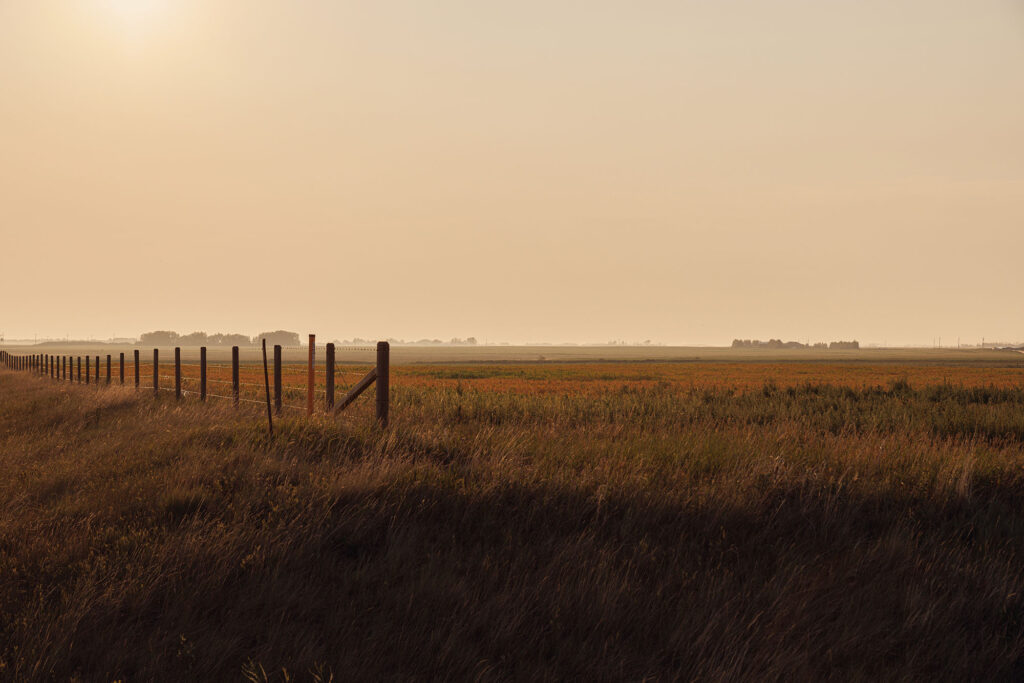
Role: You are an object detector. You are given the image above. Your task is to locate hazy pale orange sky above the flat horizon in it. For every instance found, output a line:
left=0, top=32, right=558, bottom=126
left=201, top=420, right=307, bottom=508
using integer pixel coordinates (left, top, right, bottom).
left=0, top=0, right=1024, bottom=344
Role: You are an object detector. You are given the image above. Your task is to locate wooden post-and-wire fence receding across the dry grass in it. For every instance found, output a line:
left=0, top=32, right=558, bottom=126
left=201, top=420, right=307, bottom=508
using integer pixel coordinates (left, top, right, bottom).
left=0, top=335, right=391, bottom=426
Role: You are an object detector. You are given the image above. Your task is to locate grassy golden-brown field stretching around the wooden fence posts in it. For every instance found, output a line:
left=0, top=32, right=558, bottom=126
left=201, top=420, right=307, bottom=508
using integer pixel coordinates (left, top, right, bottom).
left=0, top=350, right=1024, bottom=681
